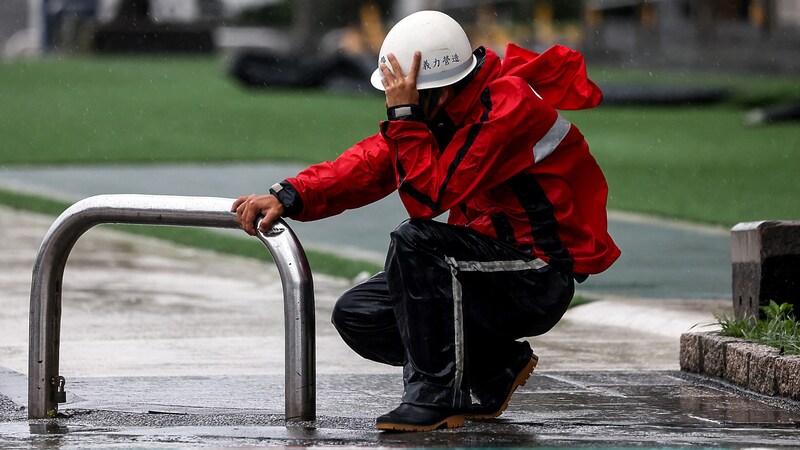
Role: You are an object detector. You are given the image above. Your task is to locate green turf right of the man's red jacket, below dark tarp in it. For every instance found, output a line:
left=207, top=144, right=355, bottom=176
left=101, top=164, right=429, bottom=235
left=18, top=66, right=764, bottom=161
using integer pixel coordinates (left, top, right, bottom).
left=568, top=105, right=800, bottom=226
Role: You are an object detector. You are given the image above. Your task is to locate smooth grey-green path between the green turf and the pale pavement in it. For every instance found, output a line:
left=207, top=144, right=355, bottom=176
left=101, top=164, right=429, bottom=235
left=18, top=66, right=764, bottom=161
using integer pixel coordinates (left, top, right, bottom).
left=0, top=164, right=731, bottom=300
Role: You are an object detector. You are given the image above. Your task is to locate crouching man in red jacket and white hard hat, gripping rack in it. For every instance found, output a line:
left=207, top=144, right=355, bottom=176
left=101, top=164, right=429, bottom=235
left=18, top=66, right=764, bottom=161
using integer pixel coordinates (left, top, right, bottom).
left=232, top=11, right=620, bottom=431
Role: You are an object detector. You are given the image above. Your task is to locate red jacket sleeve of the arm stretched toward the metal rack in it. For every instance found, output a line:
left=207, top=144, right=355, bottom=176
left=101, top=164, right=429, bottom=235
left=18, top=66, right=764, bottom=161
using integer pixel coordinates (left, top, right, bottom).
left=285, top=135, right=396, bottom=221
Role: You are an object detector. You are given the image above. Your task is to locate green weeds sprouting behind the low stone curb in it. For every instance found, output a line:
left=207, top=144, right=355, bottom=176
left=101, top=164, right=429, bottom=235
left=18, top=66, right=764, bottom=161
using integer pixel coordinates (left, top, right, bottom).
left=717, top=300, right=800, bottom=355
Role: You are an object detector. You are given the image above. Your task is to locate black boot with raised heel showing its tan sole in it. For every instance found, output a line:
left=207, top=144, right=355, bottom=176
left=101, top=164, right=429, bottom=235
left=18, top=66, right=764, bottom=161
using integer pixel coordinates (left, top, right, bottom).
left=466, top=345, right=539, bottom=420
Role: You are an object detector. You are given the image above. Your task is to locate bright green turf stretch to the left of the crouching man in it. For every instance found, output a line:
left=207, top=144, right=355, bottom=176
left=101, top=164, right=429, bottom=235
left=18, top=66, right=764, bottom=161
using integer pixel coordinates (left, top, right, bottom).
left=0, top=58, right=384, bottom=165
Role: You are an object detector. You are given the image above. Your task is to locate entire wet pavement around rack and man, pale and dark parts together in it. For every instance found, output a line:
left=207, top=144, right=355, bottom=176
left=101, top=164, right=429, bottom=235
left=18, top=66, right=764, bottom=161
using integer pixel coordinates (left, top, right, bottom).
left=0, top=208, right=800, bottom=448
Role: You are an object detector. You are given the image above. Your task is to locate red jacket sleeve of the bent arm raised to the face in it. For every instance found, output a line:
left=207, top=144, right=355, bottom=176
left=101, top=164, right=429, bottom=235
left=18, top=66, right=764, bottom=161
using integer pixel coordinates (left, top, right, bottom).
left=381, top=77, right=559, bottom=219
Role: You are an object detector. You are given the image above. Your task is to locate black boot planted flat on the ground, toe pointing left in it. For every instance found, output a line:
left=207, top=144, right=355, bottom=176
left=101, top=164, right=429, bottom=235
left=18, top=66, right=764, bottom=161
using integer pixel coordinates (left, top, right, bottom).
left=375, top=403, right=464, bottom=431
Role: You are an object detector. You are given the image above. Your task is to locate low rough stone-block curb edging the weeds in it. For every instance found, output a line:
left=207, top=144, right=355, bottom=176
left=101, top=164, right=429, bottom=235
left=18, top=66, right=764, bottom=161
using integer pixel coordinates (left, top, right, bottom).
left=680, top=332, right=800, bottom=400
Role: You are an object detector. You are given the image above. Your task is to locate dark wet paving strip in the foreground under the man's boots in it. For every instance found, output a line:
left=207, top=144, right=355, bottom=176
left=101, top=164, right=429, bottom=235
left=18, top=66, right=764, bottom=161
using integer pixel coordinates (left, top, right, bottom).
left=0, top=371, right=800, bottom=448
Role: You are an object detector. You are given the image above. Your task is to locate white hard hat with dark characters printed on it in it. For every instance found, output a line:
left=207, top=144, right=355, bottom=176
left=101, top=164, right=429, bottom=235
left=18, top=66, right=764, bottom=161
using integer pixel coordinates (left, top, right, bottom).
left=370, top=11, right=477, bottom=90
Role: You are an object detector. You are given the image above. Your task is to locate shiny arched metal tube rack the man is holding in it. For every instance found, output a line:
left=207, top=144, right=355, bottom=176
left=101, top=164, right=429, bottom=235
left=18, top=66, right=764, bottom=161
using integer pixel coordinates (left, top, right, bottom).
left=28, top=195, right=316, bottom=420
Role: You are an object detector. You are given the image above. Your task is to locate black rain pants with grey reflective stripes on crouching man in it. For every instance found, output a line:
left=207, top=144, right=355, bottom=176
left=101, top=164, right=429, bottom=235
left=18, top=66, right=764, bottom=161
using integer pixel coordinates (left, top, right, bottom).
left=332, top=219, right=574, bottom=410
